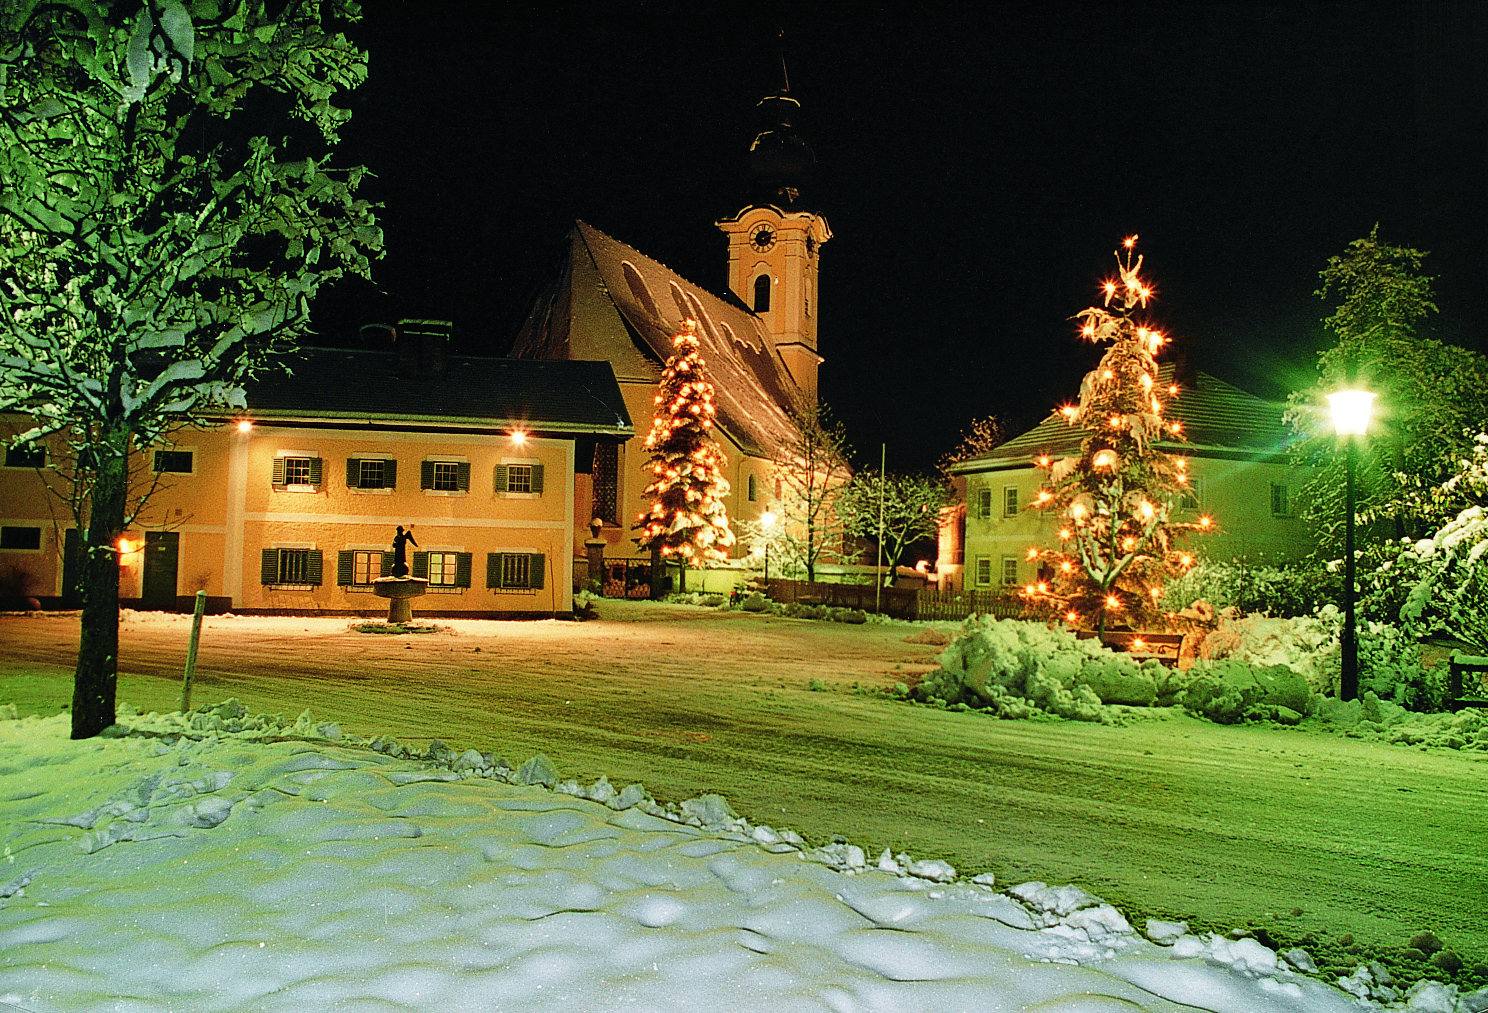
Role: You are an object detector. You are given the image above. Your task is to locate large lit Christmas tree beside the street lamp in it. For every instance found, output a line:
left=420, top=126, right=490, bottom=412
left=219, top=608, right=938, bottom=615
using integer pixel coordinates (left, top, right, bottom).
left=1024, top=237, right=1214, bottom=631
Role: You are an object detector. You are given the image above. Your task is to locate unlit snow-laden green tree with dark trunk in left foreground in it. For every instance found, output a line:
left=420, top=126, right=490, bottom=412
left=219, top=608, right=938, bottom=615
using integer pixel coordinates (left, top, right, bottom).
left=0, top=0, right=382, bottom=738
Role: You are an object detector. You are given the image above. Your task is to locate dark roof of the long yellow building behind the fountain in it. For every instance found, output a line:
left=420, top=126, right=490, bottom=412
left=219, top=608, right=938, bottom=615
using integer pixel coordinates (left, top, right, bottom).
left=247, top=348, right=635, bottom=436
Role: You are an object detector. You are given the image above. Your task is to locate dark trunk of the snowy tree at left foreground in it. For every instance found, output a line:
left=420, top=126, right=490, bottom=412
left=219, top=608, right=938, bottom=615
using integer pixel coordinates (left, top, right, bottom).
left=73, top=430, right=129, bottom=739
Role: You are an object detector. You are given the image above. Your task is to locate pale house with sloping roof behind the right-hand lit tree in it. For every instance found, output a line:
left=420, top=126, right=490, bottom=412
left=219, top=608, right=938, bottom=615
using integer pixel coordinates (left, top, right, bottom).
left=936, top=363, right=1314, bottom=592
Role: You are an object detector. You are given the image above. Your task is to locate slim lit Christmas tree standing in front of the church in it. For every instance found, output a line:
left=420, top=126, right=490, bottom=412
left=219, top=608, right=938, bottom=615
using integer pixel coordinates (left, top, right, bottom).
left=637, top=320, right=734, bottom=588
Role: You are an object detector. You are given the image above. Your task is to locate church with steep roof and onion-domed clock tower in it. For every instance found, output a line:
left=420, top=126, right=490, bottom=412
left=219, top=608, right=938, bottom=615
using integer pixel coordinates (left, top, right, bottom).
left=510, top=64, right=832, bottom=596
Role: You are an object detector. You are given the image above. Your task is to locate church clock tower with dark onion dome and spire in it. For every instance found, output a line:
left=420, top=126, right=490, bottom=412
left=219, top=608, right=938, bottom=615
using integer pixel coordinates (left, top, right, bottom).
left=717, top=49, right=832, bottom=399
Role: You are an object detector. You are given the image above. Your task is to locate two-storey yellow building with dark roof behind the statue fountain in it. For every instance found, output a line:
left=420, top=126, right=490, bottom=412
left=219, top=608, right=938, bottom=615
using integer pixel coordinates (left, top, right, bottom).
left=0, top=333, right=634, bottom=617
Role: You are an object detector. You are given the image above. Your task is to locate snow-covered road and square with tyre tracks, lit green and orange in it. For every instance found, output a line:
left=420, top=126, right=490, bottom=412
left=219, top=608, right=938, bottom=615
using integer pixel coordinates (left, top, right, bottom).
left=0, top=602, right=1488, bottom=1009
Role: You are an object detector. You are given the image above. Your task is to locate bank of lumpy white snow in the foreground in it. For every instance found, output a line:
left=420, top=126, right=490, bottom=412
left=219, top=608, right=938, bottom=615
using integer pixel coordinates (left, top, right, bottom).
left=0, top=714, right=1482, bottom=1013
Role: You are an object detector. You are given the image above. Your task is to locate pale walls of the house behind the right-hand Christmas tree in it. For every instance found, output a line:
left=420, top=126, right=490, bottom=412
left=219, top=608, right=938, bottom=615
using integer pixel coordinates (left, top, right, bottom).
left=937, top=455, right=1312, bottom=591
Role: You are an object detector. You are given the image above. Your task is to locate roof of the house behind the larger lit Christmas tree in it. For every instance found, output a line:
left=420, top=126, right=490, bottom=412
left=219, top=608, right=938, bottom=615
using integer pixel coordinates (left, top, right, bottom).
left=951, top=363, right=1293, bottom=475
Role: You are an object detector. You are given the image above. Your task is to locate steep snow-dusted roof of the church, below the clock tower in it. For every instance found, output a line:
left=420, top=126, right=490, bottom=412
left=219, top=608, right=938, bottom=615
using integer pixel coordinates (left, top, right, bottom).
left=512, top=222, right=799, bottom=457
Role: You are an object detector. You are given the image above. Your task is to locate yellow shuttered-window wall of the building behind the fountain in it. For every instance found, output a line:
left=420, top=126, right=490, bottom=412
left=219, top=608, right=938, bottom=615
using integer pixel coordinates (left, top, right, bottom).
left=0, top=424, right=574, bottom=614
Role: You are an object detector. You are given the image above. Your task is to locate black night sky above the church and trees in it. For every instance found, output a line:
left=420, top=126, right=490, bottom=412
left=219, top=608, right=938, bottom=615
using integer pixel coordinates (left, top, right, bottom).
left=308, top=1, right=1488, bottom=470
